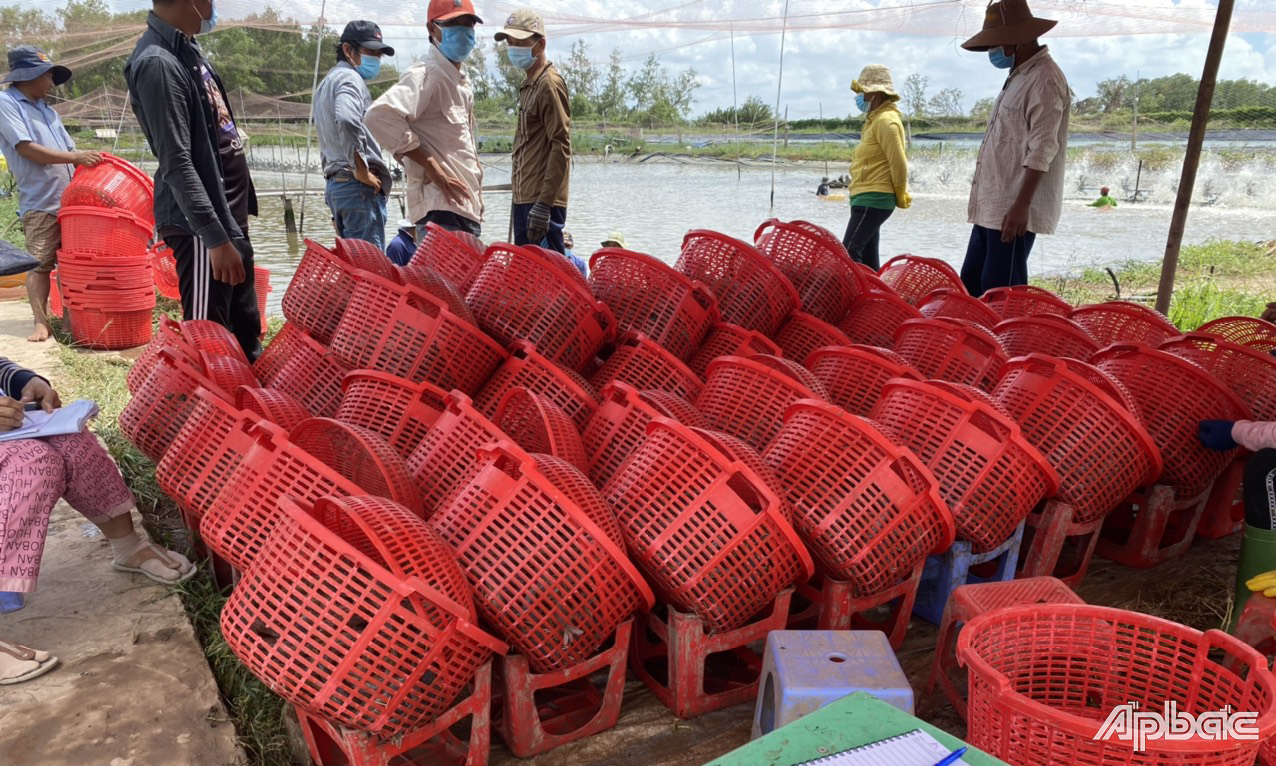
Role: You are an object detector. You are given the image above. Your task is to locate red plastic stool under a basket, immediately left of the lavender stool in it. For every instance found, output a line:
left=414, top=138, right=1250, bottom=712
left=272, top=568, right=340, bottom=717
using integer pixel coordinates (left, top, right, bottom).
left=629, top=587, right=794, bottom=719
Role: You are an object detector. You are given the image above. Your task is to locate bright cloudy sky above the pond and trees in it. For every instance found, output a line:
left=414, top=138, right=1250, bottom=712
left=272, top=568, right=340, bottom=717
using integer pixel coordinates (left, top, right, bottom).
left=22, top=0, right=1276, bottom=119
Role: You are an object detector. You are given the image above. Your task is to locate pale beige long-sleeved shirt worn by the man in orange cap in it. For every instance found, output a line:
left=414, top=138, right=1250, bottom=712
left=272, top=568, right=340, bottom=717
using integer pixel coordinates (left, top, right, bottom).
left=364, top=45, right=484, bottom=222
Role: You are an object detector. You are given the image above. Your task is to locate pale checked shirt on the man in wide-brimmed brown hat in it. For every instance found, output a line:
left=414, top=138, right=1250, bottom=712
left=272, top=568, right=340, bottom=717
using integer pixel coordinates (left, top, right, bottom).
left=966, top=49, right=1072, bottom=234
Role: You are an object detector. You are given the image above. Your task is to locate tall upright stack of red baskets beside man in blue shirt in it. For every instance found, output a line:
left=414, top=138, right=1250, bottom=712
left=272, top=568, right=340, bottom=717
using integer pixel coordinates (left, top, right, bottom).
left=57, top=154, right=156, bottom=349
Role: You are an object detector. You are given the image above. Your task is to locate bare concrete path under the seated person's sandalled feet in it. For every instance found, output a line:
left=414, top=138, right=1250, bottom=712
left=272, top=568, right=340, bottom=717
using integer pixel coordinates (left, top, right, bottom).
left=0, top=300, right=246, bottom=766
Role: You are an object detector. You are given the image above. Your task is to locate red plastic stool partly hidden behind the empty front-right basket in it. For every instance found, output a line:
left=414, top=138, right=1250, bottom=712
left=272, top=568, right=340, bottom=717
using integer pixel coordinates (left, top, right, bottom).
left=926, top=577, right=1085, bottom=720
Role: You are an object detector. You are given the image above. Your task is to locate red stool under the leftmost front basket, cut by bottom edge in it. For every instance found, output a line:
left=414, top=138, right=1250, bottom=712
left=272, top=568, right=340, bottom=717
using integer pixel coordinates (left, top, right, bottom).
left=296, top=663, right=491, bottom=766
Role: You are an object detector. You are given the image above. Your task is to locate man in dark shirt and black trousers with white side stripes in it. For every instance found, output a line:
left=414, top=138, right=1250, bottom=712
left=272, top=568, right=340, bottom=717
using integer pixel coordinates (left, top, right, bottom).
left=124, top=0, right=262, bottom=360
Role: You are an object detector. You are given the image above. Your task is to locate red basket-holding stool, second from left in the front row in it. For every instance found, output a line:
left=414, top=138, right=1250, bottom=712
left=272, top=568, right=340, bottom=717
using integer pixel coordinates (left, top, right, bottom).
left=493, top=619, right=634, bottom=758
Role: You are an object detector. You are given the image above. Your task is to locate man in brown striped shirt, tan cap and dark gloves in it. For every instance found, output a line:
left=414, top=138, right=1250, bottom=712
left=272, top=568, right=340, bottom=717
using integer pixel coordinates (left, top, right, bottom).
left=496, top=8, right=572, bottom=253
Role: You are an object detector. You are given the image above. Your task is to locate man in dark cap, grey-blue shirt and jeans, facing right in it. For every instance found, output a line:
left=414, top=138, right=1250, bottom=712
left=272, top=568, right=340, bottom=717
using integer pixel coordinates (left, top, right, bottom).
left=311, top=20, right=394, bottom=249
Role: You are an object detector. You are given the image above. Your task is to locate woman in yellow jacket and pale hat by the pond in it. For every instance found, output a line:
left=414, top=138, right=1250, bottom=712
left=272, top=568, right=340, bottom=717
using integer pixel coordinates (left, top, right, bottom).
left=842, top=64, right=912, bottom=271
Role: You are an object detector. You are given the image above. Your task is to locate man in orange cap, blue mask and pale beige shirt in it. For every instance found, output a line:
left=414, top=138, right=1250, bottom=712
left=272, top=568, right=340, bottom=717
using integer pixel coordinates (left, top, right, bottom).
left=364, top=0, right=484, bottom=241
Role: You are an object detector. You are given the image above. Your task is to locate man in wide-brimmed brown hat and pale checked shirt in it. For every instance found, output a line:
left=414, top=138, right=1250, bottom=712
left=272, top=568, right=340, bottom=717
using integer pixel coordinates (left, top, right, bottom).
left=961, top=0, right=1072, bottom=297
